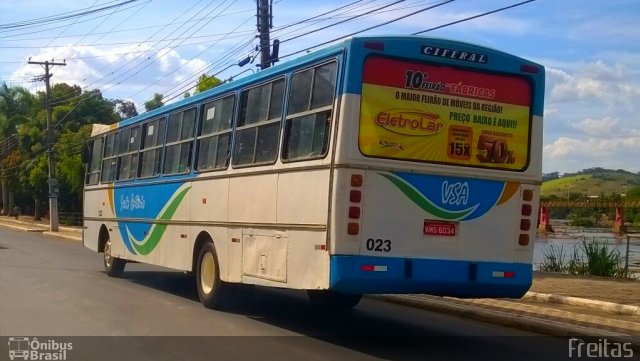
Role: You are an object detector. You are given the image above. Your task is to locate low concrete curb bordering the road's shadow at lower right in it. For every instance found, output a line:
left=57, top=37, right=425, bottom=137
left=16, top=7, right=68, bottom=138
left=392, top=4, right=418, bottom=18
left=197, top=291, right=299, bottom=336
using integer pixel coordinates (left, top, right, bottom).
left=367, top=295, right=640, bottom=347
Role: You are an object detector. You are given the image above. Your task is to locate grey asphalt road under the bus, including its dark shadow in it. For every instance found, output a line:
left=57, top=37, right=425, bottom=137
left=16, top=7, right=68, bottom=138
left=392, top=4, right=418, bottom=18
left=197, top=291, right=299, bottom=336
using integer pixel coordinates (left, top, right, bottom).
left=0, top=228, right=580, bottom=361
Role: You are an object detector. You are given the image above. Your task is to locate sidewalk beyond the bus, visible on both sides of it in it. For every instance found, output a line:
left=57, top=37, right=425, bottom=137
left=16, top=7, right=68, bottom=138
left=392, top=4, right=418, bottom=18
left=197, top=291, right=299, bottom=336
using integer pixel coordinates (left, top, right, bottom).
left=0, top=217, right=640, bottom=347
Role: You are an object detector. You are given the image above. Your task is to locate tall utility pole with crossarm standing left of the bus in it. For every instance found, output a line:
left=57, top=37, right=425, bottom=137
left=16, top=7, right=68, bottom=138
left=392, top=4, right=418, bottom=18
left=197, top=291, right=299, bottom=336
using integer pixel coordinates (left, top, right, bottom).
left=29, top=60, right=67, bottom=232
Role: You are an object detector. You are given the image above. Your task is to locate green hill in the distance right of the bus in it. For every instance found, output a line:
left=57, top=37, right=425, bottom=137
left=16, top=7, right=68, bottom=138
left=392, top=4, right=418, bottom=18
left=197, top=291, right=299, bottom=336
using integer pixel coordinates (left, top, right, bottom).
left=540, top=168, right=640, bottom=199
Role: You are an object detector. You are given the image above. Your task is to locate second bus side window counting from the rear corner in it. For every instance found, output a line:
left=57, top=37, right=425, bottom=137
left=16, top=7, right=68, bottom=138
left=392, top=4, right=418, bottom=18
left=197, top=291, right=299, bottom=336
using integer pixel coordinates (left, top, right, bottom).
left=233, top=78, right=285, bottom=165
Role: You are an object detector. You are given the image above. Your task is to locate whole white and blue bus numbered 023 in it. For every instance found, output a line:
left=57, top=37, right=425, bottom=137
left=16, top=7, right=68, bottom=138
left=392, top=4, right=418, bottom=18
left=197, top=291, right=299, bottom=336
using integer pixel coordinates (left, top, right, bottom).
left=84, top=36, right=544, bottom=308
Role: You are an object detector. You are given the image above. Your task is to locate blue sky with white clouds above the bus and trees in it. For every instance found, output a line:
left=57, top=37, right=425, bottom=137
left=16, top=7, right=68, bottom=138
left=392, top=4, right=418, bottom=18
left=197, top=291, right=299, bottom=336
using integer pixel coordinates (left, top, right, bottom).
left=0, top=0, right=640, bottom=173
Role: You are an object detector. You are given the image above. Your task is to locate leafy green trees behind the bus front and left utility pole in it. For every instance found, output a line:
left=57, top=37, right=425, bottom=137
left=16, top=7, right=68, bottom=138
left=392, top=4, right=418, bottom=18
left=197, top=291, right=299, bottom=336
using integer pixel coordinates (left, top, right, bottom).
left=0, top=75, right=221, bottom=224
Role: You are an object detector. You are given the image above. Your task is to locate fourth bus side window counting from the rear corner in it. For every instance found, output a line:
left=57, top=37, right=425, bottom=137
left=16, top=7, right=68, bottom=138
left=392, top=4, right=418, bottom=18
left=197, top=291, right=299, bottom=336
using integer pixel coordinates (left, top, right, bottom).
left=162, top=108, right=196, bottom=174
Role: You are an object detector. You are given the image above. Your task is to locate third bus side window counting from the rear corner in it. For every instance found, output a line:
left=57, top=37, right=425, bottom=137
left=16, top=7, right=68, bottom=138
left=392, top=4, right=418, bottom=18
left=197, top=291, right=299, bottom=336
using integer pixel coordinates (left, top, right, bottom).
left=196, top=95, right=235, bottom=171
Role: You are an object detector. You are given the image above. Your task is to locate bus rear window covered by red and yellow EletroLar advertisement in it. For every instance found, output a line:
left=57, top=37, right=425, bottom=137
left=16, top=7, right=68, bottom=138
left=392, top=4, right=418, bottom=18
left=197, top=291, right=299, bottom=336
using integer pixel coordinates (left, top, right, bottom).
left=358, top=57, right=532, bottom=171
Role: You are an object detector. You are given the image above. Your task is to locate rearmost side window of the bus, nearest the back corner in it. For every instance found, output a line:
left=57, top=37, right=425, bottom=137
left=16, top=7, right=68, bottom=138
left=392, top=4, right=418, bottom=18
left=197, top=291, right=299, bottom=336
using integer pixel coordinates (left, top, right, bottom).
left=282, top=62, right=338, bottom=161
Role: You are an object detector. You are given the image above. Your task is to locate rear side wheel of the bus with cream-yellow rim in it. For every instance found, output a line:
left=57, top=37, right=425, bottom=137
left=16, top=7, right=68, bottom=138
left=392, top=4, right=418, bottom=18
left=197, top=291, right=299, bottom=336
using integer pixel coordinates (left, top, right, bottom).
left=196, top=242, right=232, bottom=310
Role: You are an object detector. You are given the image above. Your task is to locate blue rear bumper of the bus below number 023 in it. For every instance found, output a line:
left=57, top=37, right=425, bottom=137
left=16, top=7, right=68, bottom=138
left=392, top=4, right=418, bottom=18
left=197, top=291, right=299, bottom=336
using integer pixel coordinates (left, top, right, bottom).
left=330, top=256, right=533, bottom=298
